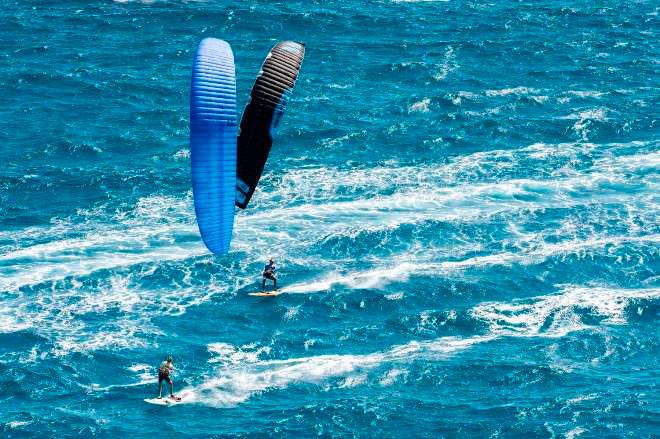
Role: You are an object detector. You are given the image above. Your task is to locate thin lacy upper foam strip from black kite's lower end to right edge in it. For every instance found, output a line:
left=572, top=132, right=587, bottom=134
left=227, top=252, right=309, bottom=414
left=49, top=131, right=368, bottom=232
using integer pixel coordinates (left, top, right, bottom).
left=250, top=141, right=658, bottom=209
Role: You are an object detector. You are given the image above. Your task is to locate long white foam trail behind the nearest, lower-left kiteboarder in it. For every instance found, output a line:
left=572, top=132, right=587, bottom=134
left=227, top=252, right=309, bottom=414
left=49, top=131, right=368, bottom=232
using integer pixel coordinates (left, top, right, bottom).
left=182, top=286, right=660, bottom=407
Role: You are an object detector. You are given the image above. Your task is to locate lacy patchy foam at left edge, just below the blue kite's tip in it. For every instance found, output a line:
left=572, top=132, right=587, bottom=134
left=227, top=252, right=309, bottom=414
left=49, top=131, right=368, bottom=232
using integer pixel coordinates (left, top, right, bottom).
left=0, top=267, right=228, bottom=363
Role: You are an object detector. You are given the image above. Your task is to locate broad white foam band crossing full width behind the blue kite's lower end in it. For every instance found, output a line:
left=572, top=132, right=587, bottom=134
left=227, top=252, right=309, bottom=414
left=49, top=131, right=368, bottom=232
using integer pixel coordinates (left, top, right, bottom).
left=0, top=144, right=660, bottom=291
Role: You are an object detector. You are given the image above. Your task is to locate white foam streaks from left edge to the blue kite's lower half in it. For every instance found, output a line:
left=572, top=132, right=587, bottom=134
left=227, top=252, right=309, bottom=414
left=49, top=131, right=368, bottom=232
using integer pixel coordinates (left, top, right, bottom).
left=0, top=196, right=205, bottom=291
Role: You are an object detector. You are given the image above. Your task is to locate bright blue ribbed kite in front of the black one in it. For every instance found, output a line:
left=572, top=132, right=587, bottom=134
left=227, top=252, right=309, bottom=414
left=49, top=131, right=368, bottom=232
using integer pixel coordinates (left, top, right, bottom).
left=190, top=38, right=237, bottom=254
